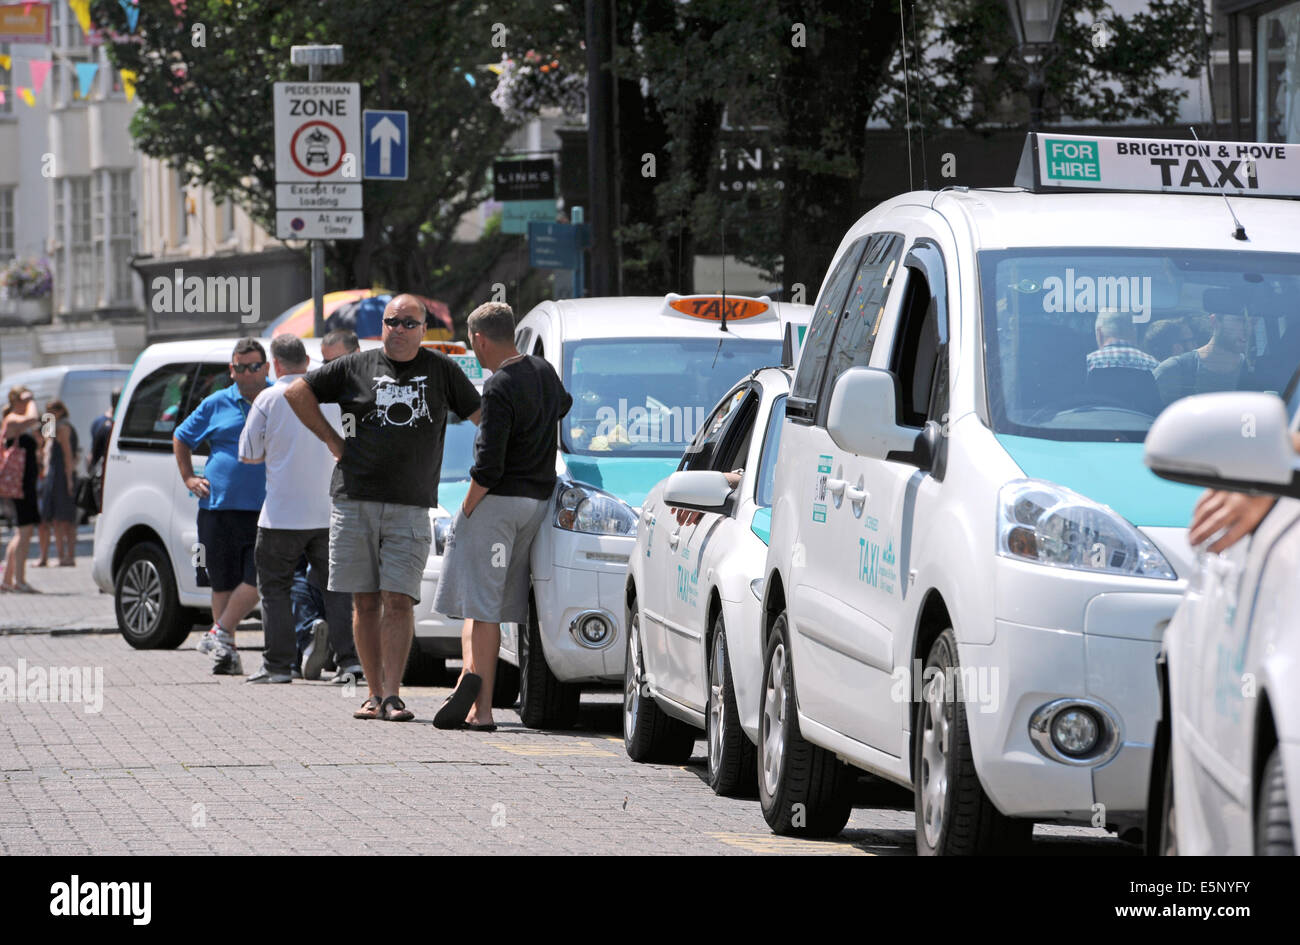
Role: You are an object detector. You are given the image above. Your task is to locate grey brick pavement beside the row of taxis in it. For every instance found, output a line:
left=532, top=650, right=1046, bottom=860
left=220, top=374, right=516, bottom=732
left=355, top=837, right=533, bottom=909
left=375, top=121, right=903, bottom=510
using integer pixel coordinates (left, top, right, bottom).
left=0, top=629, right=1132, bottom=855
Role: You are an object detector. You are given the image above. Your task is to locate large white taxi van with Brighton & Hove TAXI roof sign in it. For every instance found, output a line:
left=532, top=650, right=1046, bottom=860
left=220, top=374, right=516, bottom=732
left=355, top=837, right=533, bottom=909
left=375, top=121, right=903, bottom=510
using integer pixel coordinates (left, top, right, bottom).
left=758, top=134, right=1300, bottom=854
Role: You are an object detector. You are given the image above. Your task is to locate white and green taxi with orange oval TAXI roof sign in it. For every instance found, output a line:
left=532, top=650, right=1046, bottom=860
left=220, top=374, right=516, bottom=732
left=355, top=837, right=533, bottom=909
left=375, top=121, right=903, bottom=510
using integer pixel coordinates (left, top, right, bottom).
left=502, top=295, right=810, bottom=728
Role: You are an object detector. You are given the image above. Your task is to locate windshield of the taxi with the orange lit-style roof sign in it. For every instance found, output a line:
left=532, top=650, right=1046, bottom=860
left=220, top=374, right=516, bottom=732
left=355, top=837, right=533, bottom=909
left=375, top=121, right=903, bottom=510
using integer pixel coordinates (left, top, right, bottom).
left=560, top=331, right=781, bottom=458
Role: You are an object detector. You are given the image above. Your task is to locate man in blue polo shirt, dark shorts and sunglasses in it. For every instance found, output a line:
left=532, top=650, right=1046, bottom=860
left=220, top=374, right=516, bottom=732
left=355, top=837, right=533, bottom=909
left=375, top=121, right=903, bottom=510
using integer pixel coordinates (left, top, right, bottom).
left=172, top=338, right=268, bottom=676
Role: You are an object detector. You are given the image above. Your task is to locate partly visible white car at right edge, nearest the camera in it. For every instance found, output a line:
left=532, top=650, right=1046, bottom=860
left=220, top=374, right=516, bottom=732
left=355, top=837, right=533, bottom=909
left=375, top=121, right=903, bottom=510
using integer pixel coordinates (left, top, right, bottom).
left=1147, top=387, right=1300, bottom=855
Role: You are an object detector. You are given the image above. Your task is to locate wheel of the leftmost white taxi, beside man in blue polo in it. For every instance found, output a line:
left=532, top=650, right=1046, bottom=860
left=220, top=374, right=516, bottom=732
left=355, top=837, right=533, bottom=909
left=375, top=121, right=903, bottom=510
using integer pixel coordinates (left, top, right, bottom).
left=113, top=541, right=195, bottom=650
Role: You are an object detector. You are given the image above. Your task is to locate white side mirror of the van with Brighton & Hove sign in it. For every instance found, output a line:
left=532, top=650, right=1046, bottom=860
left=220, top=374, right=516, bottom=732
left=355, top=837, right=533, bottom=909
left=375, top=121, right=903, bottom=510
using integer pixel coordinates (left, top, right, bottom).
left=826, top=368, right=927, bottom=459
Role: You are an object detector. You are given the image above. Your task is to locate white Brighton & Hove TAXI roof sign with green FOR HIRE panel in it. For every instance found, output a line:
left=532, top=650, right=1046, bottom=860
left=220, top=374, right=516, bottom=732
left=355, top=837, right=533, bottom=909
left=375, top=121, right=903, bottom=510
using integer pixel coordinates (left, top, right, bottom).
left=1015, top=131, right=1300, bottom=198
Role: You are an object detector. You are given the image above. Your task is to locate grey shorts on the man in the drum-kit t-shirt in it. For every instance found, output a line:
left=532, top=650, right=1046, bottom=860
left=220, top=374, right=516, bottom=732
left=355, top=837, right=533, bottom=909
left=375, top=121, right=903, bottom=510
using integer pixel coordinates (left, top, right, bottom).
left=329, top=498, right=433, bottom=602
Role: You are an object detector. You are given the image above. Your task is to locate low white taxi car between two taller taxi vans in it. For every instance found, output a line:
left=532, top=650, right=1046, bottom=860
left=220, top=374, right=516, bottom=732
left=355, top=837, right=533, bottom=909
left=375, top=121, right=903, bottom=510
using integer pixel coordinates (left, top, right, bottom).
left=623, top=368, right=790, bottom=794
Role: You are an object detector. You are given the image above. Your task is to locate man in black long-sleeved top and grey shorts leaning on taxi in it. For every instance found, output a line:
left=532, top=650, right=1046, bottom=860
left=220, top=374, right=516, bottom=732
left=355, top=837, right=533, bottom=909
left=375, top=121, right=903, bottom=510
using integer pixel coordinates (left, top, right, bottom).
left=433, top=302, right=573, bottom=732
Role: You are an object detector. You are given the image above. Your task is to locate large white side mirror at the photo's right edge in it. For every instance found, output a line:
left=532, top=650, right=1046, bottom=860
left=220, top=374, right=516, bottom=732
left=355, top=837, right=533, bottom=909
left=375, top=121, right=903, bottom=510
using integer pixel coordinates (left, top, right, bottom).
left=1143, top=391, right=1300, bottom=498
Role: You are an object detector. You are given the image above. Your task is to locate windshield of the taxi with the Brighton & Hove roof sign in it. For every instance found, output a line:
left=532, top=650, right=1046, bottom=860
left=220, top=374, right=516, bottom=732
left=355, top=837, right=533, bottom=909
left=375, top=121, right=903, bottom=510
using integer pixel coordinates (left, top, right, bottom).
left=979, top=248, right=1300, bottom=442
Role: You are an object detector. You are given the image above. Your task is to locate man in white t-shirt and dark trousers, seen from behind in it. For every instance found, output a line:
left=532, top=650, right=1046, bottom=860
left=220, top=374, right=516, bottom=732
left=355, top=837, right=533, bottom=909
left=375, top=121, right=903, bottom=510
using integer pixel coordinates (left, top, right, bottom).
left=239, top=334, right=360, bottom=682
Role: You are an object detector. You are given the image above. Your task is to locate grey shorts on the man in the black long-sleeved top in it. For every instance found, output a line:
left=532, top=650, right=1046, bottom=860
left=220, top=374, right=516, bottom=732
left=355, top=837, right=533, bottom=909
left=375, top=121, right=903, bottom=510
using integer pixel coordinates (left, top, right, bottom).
left=433, top=495, right=550, bottom=624
